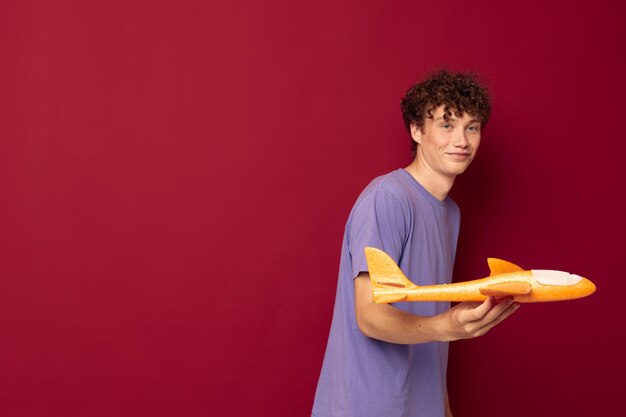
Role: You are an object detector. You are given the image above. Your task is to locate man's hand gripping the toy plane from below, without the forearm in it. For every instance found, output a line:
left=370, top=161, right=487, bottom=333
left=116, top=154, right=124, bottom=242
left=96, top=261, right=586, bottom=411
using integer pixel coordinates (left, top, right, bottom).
left=442, top=297, right=519, bottom=341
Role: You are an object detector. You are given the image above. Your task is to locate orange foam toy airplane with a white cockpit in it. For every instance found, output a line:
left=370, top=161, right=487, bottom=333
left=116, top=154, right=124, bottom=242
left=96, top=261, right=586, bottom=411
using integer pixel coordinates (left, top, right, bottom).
left=365, top=247, right=596, bottom=303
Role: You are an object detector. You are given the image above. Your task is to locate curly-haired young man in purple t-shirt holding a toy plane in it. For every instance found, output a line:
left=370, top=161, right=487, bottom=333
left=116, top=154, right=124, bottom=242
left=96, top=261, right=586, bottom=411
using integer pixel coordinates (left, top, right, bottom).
left=312, top=71, right=518, bottom=417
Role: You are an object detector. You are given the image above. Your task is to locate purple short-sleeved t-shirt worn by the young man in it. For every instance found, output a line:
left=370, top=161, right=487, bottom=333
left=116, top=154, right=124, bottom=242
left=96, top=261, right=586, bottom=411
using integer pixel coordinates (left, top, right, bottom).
left=312, top=169, right=459, bottom=417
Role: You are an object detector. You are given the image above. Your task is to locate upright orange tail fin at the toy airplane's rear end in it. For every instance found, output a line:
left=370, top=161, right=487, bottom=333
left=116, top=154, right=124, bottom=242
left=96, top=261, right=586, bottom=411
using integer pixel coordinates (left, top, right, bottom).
left=365, top=247, right=417, bottom=303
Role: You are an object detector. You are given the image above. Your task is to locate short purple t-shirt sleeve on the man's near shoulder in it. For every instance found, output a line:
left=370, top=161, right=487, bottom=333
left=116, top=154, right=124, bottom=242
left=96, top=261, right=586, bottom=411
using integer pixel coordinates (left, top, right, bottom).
left=348, top=188, right=409, bottom=279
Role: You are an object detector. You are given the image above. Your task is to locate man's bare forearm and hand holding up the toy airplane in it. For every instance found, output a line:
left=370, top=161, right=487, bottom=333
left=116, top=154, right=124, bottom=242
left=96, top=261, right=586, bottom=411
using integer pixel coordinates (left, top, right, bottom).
left=354, top=272, right=519, bottom=344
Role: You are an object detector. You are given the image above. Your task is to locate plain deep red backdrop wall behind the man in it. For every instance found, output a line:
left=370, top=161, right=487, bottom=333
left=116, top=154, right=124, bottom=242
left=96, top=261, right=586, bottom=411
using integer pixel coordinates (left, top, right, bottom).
left=0, top=0, right=626, bottom=416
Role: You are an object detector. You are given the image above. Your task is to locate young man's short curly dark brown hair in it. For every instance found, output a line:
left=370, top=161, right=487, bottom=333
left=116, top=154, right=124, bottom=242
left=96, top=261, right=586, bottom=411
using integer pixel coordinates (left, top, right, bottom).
left=400, top=70, right=491, bottom=154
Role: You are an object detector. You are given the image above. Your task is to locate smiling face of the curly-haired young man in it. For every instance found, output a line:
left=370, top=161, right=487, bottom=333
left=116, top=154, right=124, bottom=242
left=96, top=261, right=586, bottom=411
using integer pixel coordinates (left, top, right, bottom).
left=411, top=106, right=480, bottom=177
